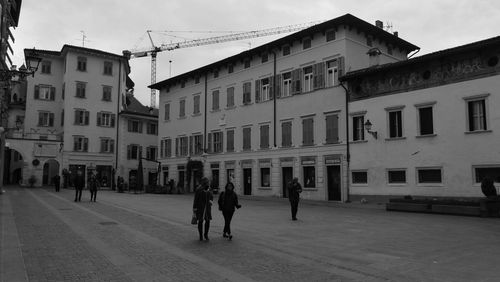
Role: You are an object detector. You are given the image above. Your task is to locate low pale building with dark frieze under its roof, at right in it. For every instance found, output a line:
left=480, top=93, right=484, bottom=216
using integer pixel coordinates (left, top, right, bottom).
left=342, top=37, right=500, bottom=197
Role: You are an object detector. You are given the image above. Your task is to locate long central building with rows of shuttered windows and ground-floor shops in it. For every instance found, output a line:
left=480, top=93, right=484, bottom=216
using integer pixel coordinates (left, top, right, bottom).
left=150, top=14, right=418, bottom=201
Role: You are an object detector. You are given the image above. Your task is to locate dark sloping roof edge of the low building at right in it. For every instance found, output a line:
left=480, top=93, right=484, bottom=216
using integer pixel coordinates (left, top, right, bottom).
left=340, top=36, right=500, bottom=81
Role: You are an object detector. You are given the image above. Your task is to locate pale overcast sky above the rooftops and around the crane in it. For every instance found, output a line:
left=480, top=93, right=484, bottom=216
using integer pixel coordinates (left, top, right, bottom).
left=13, top=0, right=500, bottom=105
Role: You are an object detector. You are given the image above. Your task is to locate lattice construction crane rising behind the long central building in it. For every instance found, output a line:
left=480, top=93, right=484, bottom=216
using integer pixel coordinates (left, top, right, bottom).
left=128, top=21, right=322, bottom=108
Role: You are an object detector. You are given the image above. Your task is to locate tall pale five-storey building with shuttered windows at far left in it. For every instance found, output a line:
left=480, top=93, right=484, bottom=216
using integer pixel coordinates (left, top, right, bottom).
left=3, top=45, right=130, bottom=187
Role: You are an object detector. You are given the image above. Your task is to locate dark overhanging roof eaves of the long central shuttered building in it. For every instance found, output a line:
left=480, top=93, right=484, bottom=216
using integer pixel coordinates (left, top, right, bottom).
left=148, top=14, right=420, bottom=90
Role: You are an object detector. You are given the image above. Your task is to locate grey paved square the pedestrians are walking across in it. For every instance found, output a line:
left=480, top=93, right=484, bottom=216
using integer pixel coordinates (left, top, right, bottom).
left=0, top=187, right=500, bottom=282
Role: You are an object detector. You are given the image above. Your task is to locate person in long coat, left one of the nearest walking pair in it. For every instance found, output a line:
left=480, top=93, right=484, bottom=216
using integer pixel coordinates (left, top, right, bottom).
left=193, top=177, right=214, bottom=241
